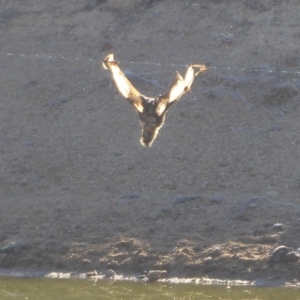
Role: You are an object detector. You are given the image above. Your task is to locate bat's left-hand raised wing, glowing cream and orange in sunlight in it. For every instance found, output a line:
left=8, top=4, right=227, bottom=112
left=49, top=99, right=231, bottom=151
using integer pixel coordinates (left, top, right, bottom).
left=103, top=54, right=143, bottom=113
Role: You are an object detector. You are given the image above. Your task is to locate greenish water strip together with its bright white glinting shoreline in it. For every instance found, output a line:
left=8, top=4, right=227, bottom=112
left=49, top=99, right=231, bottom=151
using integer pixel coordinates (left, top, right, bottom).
left=0, top=270, right=300, bottom=300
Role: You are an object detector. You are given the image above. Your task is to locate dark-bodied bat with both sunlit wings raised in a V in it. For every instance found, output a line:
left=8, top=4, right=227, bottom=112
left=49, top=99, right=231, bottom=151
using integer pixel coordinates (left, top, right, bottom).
left=103, top=54, right=207, bottom=147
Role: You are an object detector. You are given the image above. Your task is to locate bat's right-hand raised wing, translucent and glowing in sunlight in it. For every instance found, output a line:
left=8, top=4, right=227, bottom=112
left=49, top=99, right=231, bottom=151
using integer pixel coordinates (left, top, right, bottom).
left=156, top=64, right=207, bottom=115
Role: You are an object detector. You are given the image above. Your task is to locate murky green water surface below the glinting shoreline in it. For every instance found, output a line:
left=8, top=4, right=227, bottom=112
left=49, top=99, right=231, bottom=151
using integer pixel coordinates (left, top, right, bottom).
left=0, top=278, right=300, bottom=300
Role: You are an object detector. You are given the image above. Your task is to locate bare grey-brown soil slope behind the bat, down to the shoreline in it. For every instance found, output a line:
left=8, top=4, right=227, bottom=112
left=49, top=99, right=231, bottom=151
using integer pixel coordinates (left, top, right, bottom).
left=0, top=0, right=300, bottom=281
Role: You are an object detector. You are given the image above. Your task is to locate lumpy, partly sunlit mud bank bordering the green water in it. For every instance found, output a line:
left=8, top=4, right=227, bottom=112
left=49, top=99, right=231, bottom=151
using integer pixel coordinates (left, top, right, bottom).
left=1, top=239, right=300, bottom=285
